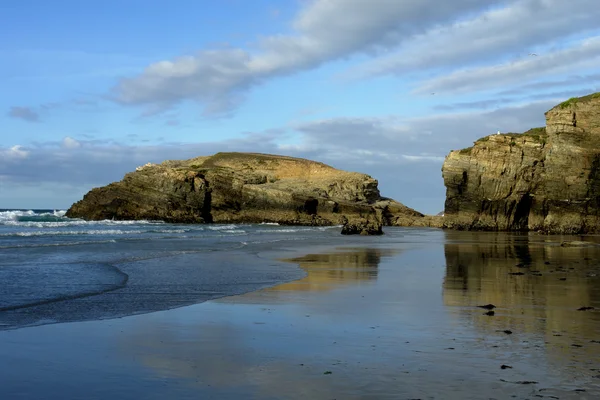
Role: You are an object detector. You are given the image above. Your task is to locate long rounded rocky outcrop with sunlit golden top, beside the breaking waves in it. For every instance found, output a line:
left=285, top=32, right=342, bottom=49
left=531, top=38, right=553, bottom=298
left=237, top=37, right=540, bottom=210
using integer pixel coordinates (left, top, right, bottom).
left=67, top=153, right=423, bottom=225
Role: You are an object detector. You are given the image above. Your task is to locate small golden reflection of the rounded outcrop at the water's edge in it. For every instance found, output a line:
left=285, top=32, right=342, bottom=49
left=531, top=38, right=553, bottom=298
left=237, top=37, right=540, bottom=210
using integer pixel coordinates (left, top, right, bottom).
left=266, top=248, right=398, bottom=292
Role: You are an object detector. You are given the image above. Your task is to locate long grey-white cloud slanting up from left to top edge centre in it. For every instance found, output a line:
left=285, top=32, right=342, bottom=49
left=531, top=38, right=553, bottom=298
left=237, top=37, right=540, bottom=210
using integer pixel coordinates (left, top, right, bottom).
left=112, top=0, right=503, bottom=115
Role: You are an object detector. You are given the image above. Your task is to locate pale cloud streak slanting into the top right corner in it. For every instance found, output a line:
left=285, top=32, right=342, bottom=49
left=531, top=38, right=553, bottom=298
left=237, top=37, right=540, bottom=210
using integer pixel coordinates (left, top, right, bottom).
left=345, top=0, right=600, bottom=77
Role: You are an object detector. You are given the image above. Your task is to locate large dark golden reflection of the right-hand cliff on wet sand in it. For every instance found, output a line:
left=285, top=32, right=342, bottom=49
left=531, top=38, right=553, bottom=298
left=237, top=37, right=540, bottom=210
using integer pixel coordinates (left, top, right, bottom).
left=444, top=232, right=600, bottom=375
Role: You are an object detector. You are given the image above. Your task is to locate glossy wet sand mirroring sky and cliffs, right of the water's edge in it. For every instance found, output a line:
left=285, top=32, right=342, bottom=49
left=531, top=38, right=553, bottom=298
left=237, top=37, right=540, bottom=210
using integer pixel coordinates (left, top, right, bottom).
left=0, top=230, right=600, bottom=399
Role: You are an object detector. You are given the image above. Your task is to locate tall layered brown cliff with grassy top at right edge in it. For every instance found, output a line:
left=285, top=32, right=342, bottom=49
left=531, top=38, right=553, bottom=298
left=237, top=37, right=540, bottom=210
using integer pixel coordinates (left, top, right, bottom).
left=442, top=94, right=600, bottom=233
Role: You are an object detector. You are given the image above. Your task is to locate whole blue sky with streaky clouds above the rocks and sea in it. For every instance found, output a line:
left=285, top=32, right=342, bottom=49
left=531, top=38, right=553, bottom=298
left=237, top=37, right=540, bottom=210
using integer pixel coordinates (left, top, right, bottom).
left=0, top=0, right=600, bottom=214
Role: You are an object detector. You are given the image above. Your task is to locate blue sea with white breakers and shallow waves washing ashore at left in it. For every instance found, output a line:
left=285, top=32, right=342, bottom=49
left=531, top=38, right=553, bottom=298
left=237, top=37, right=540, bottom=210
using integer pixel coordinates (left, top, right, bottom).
left=0, top=209, right=404, bottom=330
